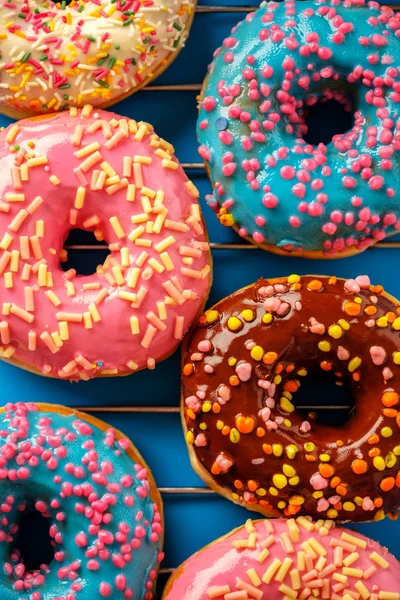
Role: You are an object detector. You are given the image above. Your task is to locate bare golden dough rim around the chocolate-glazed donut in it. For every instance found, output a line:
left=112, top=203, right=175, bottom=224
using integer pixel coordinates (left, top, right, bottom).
left=180, top=274, right=400, bottom=524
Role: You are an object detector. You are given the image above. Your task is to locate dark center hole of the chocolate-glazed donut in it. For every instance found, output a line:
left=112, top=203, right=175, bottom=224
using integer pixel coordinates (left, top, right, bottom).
left=293, top=373, right=355, bottom=427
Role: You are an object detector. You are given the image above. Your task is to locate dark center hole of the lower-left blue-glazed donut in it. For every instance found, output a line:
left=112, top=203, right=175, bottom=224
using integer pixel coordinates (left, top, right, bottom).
left=10, top=506, right=54, bottom=572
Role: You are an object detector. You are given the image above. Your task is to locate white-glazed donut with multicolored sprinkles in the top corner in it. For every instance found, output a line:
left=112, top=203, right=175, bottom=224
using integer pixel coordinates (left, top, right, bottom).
left=0, top=0, right=196, bottom=119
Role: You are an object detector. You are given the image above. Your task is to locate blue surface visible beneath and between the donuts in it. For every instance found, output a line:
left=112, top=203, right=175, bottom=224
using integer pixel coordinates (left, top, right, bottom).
left=0, top=0, right=400, bottom=583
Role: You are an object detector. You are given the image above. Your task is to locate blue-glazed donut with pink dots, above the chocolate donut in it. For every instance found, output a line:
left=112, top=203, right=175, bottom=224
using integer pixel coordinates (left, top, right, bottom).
left=198, top=0, right=400, bottom=258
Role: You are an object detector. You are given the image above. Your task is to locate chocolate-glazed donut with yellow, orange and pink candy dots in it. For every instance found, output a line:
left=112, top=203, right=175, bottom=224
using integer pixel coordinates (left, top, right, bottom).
left=182, top=275, right=400, bottom=521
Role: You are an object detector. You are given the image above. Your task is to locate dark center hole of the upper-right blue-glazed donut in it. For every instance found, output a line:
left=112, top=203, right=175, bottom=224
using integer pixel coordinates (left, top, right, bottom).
left=302, top=95, right=354, bottom=146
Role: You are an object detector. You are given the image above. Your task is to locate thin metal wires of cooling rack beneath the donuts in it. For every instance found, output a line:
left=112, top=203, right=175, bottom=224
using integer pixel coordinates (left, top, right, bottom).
left=61, top=4, right=400, bottom=576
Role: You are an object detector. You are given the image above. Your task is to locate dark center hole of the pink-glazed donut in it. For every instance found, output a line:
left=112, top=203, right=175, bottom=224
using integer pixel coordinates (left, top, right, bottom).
left=60, top=229, right=110, bottom=275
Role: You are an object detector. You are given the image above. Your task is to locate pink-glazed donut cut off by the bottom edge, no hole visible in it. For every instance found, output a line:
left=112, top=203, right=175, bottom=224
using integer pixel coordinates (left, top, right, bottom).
left=163, top=517, right=400, bottom=600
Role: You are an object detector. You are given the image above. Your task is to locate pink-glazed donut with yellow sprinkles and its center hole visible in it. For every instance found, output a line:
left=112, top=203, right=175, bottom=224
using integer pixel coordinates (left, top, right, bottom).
left=0, top=105, right=211, bottom=380
